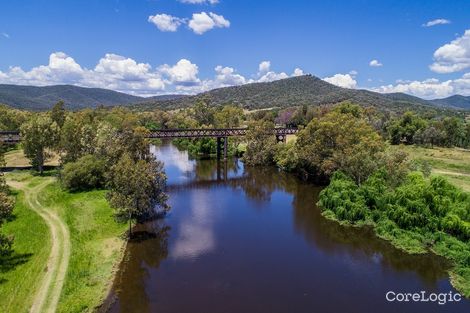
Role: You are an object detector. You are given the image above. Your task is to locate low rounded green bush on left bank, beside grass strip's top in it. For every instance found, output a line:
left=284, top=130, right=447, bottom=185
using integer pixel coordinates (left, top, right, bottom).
left=61, top=155, right=106, bottom=191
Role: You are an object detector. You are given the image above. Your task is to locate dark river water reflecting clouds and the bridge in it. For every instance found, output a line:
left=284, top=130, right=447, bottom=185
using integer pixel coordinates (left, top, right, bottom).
left=109, top=144, right=470, bottom=313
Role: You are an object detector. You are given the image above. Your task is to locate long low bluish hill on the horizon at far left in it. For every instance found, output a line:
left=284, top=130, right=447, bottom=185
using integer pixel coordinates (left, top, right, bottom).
left=0, top=85, right=145, bottom=110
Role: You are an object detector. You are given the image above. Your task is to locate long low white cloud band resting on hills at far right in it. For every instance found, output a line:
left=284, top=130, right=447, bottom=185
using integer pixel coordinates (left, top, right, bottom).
left=372, top=73, right=470, bottom=99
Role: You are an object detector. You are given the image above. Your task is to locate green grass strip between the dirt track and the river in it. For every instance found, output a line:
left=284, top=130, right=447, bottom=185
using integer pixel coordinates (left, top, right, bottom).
left=41, top=183, right=126, bottom=312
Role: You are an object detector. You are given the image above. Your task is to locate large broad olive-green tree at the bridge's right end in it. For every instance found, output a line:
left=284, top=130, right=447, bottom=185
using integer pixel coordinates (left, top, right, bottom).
left=296, top=106, right=385, bottom=182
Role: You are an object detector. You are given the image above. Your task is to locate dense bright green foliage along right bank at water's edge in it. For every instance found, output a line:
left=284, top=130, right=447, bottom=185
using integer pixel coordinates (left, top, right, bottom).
left=319, top=170, right=470, bottom=296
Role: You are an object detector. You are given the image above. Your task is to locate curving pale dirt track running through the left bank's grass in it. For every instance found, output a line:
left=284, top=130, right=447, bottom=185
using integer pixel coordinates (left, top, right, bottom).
left=8, top=178, right=70, bottom=313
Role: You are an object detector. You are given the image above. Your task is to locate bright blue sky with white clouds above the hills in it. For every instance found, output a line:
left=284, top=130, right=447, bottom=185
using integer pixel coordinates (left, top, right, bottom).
left=0, top=0, right=470, bottom=99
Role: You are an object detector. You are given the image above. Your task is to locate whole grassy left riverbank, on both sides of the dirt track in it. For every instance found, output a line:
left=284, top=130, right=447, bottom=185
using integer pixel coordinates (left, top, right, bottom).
left=0, top=172, right=126, bottom=312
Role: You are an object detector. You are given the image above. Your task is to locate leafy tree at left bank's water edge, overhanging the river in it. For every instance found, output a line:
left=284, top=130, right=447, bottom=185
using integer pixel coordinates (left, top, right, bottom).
left=107, top=153, right=169, bottom=236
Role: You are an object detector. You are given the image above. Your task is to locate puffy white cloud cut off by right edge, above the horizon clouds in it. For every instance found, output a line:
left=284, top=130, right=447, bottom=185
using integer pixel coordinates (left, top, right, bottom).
left=429, top=29, right=470, bottom=73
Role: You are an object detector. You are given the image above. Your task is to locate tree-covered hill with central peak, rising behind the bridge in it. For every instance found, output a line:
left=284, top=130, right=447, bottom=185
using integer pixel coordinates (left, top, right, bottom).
left=133, top=75, right=450, bottom=111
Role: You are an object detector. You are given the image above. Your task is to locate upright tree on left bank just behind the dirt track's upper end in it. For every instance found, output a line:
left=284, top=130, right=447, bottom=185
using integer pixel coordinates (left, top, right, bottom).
left=21, top=115, right=59, bottom=175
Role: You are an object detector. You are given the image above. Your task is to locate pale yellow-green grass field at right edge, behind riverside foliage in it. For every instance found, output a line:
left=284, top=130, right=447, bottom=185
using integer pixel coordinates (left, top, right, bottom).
left=400, top=146, right=470, bottom=192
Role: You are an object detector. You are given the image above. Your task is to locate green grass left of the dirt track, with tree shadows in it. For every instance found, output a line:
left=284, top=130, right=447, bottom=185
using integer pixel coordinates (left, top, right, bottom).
left=0, top=185, right=51, bottom=312
